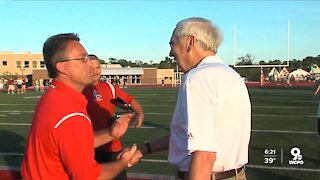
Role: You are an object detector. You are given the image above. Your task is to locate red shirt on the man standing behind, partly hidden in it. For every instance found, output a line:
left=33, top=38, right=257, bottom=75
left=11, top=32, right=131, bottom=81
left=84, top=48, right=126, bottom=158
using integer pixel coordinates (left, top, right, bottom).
left=83, top=81, right=133, bottom=152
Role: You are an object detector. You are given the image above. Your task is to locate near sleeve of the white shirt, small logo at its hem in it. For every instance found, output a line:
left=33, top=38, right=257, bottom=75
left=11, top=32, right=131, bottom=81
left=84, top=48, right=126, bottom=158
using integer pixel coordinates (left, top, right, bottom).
left=186, top=78, right=217, bottom=153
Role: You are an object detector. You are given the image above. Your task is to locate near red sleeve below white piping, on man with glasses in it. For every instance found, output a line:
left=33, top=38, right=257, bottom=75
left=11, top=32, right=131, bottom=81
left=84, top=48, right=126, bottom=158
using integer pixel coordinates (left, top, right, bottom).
left=57, top=116, right=102, bottom=180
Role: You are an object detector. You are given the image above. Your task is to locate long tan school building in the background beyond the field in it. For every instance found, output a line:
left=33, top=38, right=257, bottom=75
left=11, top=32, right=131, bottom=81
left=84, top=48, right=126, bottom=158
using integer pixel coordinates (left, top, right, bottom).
left=0, top=51, right=181, bottom=85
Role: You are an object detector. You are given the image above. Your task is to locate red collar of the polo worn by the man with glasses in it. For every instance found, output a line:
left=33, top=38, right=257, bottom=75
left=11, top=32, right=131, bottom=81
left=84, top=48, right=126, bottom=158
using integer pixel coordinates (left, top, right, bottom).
left=50, top=80, right=88, bottom=106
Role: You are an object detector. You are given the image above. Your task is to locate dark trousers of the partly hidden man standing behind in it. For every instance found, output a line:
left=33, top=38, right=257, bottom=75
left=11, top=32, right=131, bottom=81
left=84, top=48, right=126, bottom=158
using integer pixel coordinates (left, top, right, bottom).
left=94, top=151, right=127, bottom=180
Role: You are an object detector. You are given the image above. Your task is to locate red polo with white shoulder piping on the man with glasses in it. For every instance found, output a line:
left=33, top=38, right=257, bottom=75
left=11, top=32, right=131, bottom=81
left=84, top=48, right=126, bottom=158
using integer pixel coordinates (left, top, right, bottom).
left=21, top=81, right=102, bottom=180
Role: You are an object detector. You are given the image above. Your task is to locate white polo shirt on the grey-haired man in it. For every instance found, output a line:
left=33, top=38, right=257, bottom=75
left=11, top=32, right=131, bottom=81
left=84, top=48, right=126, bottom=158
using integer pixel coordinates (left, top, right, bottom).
left=168, top=56, right=251, bottom=172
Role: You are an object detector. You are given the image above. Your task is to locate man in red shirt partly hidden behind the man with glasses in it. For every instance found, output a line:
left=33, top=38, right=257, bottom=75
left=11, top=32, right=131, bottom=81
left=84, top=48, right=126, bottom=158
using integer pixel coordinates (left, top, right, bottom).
left=83, top=54, right=144, bottom=180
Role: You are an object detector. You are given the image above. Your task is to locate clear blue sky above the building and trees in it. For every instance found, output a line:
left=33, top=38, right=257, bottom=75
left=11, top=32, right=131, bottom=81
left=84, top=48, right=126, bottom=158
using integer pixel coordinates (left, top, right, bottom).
left=0, top=0, right=320, bottom=64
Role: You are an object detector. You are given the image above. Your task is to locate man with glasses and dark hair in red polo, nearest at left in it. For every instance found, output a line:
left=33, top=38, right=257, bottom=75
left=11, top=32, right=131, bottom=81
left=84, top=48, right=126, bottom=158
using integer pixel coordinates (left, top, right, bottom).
left=21, top=33, right=142, bottom=180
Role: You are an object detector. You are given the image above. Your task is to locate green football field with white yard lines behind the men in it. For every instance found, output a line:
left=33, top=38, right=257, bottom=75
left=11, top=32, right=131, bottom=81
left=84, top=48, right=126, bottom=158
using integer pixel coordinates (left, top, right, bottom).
left=0, top=87, right=320, bottom=180
